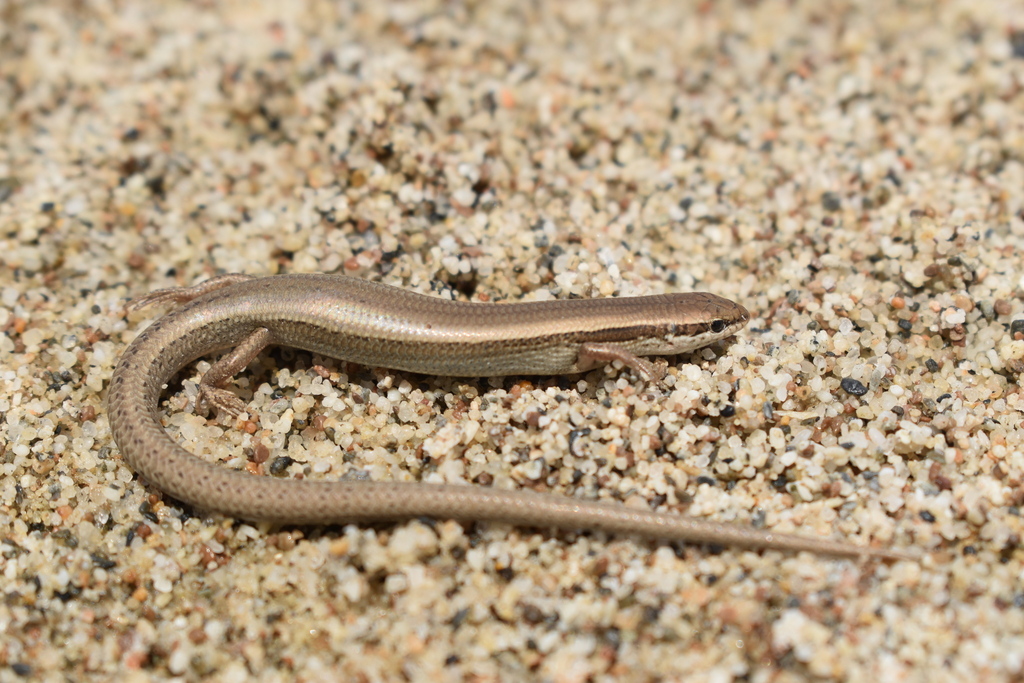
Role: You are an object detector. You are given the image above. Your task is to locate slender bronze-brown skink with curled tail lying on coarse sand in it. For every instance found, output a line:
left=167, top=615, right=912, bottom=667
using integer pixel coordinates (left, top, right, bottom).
left=108, top=274, right=909, bottom=559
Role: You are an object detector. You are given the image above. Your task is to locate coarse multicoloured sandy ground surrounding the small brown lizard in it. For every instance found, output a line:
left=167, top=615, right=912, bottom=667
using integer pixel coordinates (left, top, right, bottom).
left=0, top=0, right=1024, bottom=682
